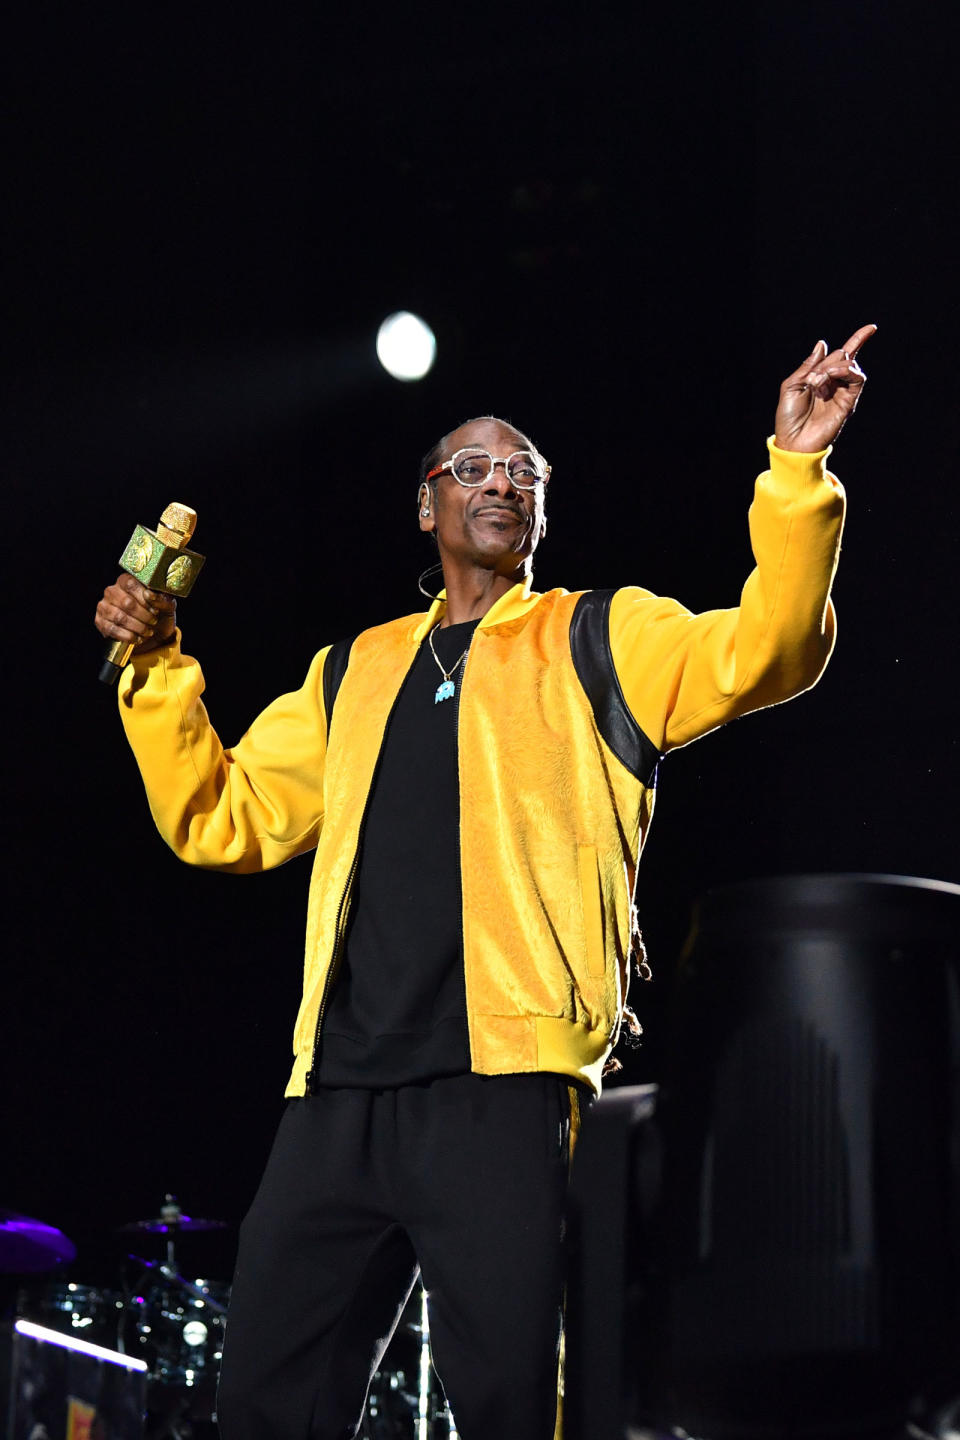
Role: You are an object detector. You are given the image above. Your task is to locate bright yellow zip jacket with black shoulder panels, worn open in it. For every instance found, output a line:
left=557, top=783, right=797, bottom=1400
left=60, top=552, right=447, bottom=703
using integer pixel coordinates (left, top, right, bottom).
left=119, top=445, right=845, bottom=1094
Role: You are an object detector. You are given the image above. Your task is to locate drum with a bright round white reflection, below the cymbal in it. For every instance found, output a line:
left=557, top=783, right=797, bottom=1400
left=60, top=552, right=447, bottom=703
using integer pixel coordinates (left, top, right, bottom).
left=124, top=1279, right=230, bottom=1420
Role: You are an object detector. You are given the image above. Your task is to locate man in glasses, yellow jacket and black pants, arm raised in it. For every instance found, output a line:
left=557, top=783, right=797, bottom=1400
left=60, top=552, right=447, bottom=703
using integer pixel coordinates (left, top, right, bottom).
left=96, top=325, right=875, bottom=1440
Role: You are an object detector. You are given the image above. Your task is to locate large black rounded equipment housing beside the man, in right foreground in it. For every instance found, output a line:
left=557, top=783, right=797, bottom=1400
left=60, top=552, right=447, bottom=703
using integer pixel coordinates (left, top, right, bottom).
left=571, top=876, right=960, bottom=1440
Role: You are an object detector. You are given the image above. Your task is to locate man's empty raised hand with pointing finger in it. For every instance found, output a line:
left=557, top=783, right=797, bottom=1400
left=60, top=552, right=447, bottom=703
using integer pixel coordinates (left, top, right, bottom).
left=773, top=325, right=877, bottom=452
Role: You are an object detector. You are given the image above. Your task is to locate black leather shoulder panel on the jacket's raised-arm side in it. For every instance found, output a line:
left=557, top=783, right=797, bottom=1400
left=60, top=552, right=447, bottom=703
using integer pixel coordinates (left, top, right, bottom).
left=570, top=590, right=659, bottom=785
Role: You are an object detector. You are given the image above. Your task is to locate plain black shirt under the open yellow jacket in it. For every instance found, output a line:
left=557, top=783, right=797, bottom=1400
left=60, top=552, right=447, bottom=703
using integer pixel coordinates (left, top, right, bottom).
left=317, top=621, right=478, bottom=1087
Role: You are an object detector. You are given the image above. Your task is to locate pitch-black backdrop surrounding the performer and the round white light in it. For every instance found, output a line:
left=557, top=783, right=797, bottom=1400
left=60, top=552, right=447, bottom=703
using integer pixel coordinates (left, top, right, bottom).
left=0, top=0, right=960, bottom=1282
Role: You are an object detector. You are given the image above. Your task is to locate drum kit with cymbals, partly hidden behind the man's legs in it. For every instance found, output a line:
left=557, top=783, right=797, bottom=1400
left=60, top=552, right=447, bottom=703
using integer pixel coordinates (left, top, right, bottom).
left=0, top=1195, right=458, bottom=1440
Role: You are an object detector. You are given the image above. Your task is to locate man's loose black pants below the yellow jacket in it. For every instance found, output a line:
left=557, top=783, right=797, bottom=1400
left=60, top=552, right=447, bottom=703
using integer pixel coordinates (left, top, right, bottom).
left=217, top=1074, right=570, bottom=1440
